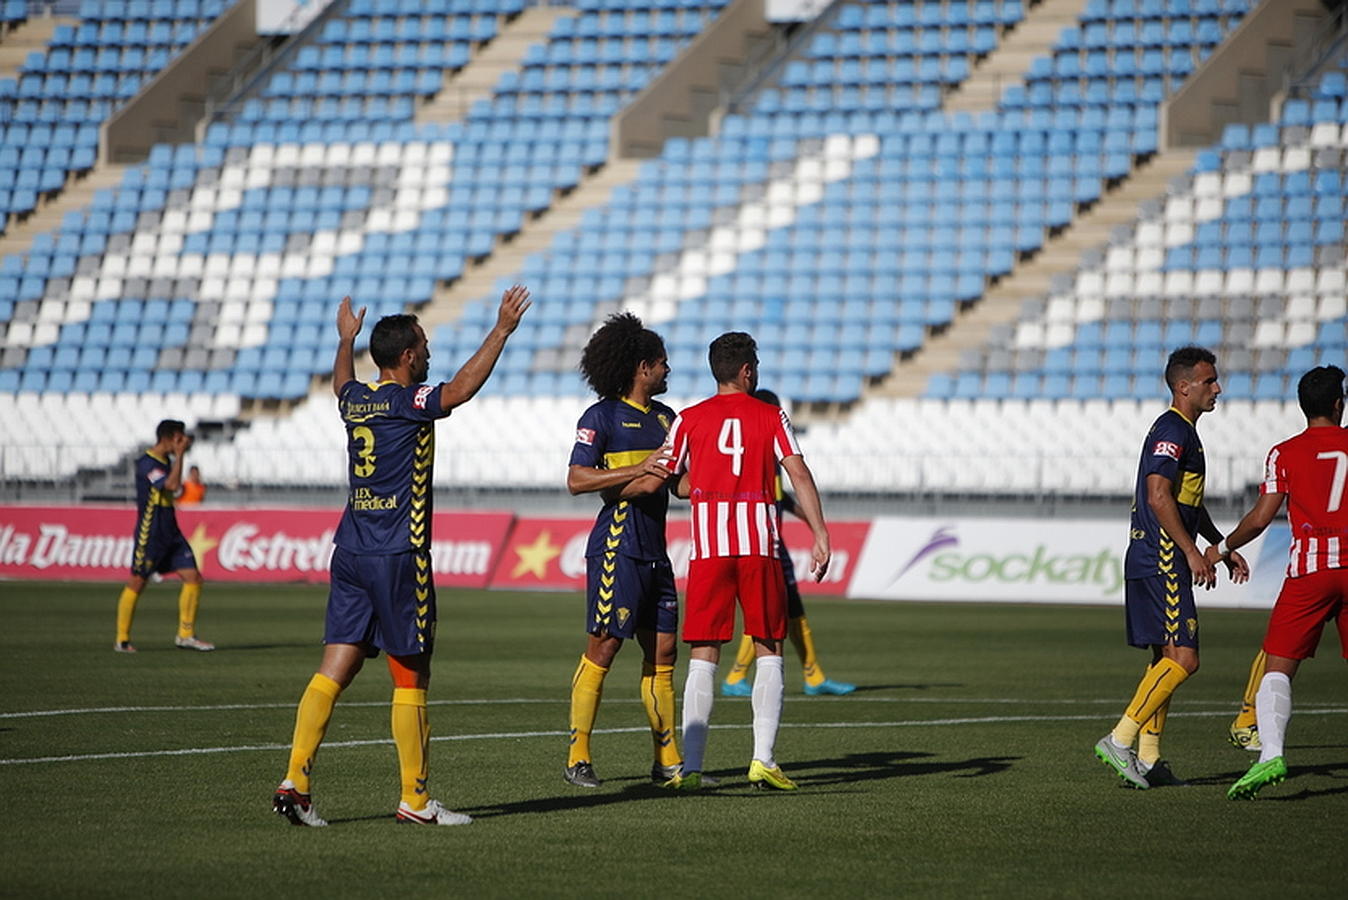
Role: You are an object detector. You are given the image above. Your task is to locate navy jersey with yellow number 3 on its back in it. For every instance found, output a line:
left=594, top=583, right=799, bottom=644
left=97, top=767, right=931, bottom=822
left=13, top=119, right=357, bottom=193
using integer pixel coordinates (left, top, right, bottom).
left=333, top=381, right=449, bottom=556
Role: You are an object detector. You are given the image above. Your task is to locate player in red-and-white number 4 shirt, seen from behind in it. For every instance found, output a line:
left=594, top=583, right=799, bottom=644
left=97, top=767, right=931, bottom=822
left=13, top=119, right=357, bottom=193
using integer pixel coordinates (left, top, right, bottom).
left=669, top=331, right=832, bottom=791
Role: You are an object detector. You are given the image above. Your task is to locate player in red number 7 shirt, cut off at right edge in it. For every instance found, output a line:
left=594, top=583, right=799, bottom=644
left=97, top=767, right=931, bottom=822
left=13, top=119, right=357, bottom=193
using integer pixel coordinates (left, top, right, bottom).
left=1206, top=365, right=1348, bottom=800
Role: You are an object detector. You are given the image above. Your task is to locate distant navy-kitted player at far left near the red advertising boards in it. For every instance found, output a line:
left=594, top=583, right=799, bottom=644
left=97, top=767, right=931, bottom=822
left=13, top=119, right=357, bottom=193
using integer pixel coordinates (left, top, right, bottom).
left=112, top=419, right=216, bottom=653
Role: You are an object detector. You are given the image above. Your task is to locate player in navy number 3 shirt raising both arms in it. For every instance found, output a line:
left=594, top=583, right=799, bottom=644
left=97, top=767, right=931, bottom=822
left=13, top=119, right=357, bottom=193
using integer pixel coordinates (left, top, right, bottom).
left=272, top=286, right=530, bottom=826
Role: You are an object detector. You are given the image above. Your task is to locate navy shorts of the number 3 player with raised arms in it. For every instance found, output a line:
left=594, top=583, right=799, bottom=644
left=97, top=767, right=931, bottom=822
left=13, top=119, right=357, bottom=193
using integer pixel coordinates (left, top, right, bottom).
left=324, top=547, right=435, bottom=656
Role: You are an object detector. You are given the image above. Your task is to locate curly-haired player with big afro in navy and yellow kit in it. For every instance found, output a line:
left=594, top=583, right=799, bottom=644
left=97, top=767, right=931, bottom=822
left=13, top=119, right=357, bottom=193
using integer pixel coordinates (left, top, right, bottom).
left=562, top=313, right=682, bottom=787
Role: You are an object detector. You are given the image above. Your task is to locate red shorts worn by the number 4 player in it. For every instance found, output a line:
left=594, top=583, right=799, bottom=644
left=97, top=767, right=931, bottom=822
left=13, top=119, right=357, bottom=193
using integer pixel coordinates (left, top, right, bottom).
left=683, top=556, right=786, bottom=644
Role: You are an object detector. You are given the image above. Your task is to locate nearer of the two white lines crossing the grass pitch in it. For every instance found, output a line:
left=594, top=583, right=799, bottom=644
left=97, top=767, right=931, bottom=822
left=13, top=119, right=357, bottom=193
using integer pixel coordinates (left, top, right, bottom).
left=0, top=706, right=1348, bottom=765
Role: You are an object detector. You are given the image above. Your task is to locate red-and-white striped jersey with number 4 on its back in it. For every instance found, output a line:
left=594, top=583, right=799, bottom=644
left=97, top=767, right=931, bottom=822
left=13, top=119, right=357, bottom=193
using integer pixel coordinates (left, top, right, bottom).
left=667, top=393, right=801, bottom=559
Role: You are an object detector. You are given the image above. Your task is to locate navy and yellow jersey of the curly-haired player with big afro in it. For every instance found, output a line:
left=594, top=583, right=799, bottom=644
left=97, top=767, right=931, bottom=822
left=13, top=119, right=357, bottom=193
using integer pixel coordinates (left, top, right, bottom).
left=570, top=399, right=674, bottom=559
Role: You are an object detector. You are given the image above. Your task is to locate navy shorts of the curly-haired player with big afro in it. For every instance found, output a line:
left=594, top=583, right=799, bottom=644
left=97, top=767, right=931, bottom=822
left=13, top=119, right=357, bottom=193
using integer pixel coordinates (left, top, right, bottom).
left=585, top=554, right=678, bottom=640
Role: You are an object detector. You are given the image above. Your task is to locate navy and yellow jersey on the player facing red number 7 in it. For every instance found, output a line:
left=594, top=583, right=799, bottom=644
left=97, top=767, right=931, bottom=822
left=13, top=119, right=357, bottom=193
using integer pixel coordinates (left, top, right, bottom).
left=1123, top=407, right=1206, bottom=578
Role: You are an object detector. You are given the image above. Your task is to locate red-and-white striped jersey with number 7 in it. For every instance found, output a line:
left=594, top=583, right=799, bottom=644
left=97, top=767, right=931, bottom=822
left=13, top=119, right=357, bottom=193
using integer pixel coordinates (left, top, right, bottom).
left=1259, top=427, right=1348, bottom=578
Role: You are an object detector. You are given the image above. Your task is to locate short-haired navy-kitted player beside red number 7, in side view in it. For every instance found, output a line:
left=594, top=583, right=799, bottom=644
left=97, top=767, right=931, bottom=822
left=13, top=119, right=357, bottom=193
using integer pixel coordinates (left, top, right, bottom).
left=1095, top=346, right=1248, bottom=790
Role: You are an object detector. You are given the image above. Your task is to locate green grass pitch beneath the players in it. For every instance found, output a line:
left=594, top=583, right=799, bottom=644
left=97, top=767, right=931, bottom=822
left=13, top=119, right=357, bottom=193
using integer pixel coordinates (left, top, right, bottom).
left=0, top=582, right=1348, bottom=897
